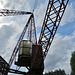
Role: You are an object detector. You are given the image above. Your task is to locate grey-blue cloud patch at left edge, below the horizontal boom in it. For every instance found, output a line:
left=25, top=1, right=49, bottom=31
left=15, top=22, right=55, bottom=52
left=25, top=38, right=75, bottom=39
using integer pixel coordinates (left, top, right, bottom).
left=0, top=26, right=14, bottom=58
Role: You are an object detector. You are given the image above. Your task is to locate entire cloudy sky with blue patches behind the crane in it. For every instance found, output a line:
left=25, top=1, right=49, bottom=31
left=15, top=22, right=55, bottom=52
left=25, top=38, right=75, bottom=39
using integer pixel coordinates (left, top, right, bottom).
left=0, top=0, right=75, bottom=75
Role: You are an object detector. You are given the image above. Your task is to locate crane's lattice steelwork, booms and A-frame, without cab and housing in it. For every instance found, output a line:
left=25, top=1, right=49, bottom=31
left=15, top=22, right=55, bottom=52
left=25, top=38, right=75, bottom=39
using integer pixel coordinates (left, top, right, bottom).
left=0, top=0, right=69, bottom=74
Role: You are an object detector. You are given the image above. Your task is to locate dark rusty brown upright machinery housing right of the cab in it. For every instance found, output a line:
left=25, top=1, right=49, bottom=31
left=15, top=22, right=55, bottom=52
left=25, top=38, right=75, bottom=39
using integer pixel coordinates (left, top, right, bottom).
left=29, top=45, right=44, bottom=75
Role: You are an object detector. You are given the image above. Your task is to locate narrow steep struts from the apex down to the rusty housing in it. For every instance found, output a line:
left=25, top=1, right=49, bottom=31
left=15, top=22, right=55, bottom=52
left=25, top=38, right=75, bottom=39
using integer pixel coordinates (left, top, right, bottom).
left=27, top=15, right=37, bottom=45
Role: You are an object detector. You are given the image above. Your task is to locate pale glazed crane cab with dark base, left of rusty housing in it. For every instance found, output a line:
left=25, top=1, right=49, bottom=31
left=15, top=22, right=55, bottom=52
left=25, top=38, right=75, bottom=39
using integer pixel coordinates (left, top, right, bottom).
left=15, top=40, right=32, bottom=66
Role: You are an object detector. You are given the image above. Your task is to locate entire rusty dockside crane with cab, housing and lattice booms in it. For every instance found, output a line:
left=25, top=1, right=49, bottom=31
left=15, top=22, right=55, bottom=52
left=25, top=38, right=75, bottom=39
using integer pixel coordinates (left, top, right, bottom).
left=0, top=0, right=69, bottom=75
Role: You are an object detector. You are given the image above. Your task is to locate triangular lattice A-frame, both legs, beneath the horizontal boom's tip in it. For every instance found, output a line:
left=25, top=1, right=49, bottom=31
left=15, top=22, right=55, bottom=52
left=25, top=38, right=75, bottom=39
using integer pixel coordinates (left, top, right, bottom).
left=9, top=14, right=37, bottom=66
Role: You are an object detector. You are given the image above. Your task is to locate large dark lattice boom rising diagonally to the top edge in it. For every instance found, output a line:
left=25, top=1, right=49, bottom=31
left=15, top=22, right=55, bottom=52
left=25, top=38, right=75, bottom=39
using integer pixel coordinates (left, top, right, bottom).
left=38, top=0, right=69, bottom=59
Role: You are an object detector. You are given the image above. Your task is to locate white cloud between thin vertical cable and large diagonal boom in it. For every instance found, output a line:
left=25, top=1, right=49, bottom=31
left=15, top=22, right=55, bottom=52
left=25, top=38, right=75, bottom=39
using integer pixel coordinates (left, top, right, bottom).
left=35, top=0, right=48, bottom=27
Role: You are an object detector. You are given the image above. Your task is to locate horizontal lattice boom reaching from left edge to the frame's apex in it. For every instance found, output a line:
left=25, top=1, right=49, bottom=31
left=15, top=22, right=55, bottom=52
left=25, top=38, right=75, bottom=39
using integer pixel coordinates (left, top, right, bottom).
left=0, top=9, right=32, bottom=16
